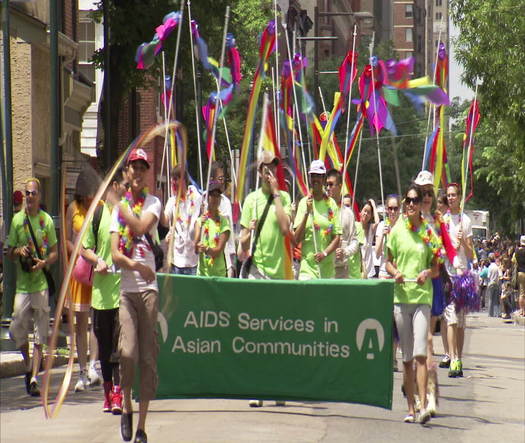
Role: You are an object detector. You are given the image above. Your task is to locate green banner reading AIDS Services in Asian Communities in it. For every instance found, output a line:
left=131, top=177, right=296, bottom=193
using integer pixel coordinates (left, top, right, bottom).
left=157, top=275, right=393, bottom=409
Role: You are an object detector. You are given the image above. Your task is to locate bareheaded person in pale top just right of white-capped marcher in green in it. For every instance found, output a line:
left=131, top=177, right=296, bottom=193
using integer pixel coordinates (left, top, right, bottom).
left=326, top=169, right=361, bottom=278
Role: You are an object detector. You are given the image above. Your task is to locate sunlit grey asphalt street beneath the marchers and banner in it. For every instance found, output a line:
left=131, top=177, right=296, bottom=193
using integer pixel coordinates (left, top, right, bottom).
left=0, top=313, right=525, bottom=443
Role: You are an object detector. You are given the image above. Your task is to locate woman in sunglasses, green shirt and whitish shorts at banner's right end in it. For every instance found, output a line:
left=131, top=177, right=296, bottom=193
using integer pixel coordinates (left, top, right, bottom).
left=386, top=185, right=441, bottom=423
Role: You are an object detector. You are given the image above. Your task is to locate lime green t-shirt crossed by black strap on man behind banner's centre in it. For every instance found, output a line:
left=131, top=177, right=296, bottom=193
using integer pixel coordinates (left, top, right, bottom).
left=241, top=188, right=291, bottom=279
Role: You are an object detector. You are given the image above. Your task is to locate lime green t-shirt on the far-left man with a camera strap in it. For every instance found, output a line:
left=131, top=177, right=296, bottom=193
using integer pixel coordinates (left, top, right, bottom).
left=7, top=210, right=57, bottom=293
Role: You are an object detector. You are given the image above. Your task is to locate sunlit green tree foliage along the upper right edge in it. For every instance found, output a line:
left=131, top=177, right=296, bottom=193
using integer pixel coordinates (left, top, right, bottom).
left=451, top=0, right=525, bottom=234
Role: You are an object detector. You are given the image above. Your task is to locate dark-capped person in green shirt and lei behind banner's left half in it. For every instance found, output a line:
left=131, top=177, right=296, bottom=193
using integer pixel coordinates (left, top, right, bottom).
left=195, top=181, right=231, bottom=277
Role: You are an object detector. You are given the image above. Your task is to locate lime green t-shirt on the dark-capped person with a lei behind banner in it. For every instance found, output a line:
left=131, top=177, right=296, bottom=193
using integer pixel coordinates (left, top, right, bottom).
left=197, top=215, right=231, bottom=277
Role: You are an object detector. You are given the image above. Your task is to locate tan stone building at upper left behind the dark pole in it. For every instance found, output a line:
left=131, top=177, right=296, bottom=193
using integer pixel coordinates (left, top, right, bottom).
left=0, top=0, right=93, bottom=215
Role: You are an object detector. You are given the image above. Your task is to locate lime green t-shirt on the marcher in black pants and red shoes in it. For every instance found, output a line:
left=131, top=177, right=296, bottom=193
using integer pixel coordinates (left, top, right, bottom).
left=82, top=204, right=120, bottom=311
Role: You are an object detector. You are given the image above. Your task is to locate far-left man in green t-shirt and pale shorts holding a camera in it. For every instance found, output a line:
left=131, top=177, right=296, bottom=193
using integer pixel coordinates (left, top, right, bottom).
left=7, top=178, right=58, bottom=397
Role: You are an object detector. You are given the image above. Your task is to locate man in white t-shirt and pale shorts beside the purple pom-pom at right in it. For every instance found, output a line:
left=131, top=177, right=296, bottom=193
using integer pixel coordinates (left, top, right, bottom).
left=443, top=183, right=474, bottom=377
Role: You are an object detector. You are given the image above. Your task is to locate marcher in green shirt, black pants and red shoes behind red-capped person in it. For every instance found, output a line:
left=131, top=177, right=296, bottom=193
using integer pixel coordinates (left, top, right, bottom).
left=82, top=168, right=127, bottom=414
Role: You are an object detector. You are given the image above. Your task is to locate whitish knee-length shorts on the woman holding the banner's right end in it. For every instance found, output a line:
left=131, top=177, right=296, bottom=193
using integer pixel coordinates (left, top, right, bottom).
left=394, top=303, right=430, bottom=362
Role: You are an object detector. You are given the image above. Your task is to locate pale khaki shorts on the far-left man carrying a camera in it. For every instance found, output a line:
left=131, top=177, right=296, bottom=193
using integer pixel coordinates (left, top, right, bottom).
left=9, top=289, right=49, bottom=348
